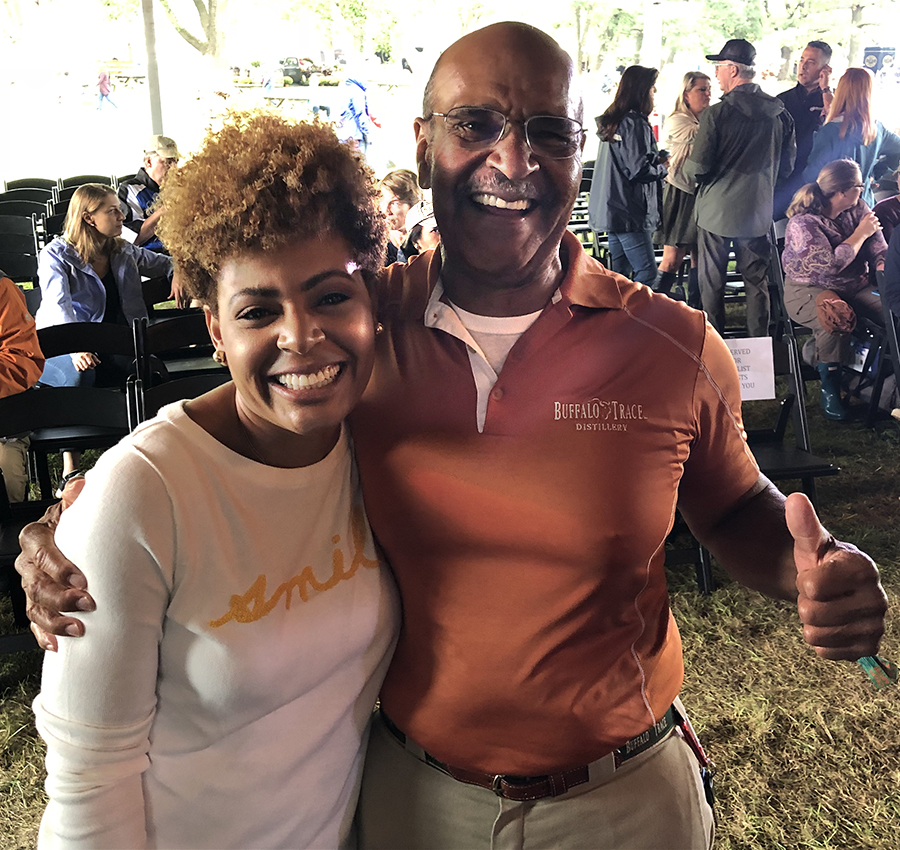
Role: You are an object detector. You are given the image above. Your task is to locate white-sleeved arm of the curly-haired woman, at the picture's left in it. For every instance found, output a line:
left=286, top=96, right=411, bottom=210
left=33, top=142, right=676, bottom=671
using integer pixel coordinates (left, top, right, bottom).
left=34, top=446, right=174, bottom=850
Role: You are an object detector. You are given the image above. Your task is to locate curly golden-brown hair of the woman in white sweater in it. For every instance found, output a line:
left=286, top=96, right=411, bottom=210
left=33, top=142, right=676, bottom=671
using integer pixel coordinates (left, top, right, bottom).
left=157, top=111, right=387, bottom=309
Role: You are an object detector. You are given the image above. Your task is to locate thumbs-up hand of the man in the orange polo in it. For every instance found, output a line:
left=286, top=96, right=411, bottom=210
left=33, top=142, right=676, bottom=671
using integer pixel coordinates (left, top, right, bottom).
left=785, top=493, right=887, bottom=661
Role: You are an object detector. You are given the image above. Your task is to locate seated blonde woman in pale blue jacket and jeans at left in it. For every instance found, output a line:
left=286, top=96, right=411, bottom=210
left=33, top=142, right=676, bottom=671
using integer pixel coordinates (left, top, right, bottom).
left=35, top=183, right=172, bottom=387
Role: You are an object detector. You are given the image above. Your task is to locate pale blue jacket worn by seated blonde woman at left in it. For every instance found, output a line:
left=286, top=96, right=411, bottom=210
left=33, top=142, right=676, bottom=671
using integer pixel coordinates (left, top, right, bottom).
left=34, top=236, right=172, bottom=328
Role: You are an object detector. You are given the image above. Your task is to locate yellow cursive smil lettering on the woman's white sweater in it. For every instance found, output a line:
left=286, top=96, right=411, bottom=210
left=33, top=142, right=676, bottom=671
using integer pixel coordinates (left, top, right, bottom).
left=209, top=506, right=378, bottom=629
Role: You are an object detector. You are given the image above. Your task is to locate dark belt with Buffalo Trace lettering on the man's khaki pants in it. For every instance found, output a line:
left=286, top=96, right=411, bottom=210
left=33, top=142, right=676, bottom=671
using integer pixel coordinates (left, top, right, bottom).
left=381, top=707, right=676, bottom=803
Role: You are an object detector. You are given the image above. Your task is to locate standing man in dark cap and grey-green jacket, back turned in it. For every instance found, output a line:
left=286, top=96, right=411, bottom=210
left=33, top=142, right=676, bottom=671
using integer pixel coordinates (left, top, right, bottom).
left=684, top=38, right=796, bottom=336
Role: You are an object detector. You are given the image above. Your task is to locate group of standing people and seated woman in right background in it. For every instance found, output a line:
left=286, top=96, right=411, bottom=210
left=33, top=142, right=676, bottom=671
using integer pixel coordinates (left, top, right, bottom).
left=589, top=39, right=900, bottom=420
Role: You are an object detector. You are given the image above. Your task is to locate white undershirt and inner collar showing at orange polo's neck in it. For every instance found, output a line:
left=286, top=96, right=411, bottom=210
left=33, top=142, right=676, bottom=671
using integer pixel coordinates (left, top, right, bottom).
left=425, top=281, right=561, bottom=434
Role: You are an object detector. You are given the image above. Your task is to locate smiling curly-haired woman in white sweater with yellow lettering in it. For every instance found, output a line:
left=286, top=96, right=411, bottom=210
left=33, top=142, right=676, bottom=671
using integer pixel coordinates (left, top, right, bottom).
left=34, top=113, right=399, bottom=848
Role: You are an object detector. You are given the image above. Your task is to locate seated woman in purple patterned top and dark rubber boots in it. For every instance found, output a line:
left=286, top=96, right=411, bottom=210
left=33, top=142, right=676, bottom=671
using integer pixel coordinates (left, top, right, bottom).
left=783, top=159, right=887, bottom=420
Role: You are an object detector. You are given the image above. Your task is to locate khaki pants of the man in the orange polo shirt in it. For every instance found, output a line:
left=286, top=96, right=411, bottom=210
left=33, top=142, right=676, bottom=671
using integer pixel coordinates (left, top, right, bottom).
left=357, top=717, right=713, bottom=850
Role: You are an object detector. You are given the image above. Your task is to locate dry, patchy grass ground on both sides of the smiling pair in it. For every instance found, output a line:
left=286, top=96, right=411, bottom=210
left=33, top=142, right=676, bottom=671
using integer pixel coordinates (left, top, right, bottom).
left=0, top=392, right=900, bottom=850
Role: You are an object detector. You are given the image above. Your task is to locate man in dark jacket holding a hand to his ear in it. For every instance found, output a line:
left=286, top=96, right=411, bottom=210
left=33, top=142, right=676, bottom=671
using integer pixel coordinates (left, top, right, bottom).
left=775, top=41, right=834, bottom=221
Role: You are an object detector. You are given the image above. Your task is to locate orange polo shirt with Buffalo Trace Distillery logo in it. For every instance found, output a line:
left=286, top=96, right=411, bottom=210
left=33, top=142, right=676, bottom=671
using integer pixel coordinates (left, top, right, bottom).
left=351, top=234, right=759, bottom=776
